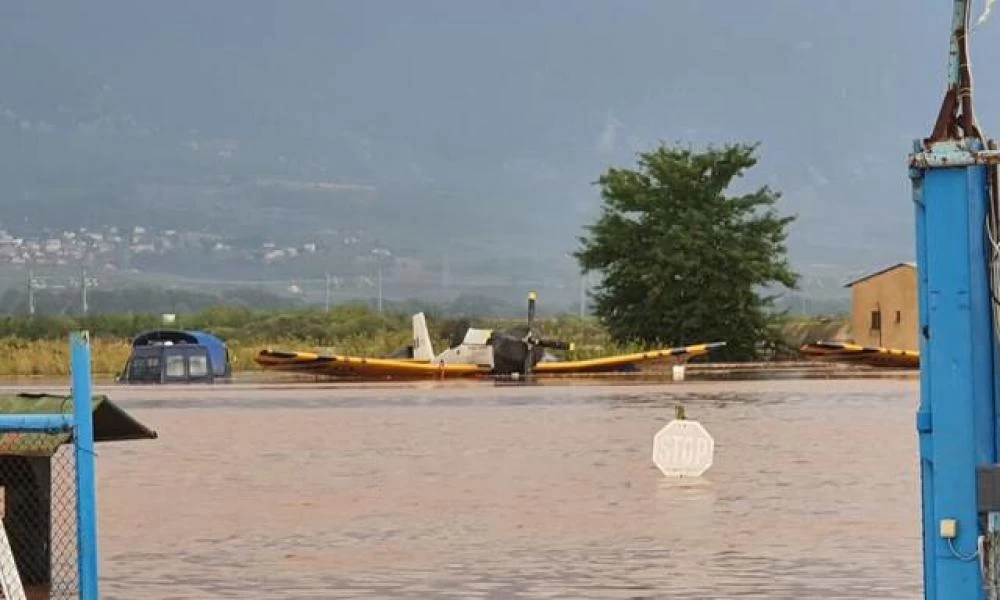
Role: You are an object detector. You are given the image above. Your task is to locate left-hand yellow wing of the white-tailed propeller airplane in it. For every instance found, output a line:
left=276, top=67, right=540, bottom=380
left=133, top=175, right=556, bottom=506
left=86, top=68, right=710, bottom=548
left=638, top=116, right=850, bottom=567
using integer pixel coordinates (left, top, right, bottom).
left=254, top=350, right=489, bottom=379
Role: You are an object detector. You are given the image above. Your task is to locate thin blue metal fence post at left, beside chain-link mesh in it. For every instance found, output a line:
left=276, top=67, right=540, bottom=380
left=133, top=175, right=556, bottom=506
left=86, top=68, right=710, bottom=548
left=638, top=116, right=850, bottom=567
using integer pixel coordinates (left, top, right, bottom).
left=70, top=332, right=100, bottom=600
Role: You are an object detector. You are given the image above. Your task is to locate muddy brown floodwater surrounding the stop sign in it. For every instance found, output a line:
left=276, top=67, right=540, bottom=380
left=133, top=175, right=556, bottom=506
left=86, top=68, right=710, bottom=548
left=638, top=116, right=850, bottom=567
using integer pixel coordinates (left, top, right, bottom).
left=23, top=380, right=921, bottom=600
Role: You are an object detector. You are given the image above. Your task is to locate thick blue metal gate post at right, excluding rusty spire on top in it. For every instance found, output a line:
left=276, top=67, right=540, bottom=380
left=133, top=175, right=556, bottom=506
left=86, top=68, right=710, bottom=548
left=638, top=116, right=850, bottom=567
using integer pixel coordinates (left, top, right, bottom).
left=911, top=142, right=996, bottom=600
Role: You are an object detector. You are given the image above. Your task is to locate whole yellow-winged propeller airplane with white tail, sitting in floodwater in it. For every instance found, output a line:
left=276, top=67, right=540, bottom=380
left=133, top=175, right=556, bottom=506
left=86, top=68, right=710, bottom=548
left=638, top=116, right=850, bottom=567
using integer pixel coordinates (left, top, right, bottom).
left=255, top=292, right=725, bottom=379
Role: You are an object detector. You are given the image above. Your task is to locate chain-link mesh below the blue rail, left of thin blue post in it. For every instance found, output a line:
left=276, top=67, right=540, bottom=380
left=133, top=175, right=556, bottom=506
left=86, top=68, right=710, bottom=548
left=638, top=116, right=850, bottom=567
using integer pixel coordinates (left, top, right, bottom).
left=0, top=431, right=80, bottom=600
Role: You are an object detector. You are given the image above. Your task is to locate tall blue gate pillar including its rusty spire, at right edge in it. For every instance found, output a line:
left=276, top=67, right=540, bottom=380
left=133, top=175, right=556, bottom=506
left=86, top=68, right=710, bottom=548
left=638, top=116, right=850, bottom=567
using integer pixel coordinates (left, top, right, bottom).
left=909, top=0, right=1000, bottom=600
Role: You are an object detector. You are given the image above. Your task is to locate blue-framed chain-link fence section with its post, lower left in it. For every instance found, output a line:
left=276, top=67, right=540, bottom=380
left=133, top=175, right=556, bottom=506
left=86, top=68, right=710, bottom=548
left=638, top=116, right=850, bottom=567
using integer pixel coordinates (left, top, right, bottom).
left=0, top=334, right=98, bottom=600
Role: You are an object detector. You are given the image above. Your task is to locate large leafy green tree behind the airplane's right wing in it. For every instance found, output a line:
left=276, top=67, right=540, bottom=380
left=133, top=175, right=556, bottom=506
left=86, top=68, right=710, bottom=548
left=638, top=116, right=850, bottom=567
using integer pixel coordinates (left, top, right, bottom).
left=575, top=144, right=798, bottom=360
